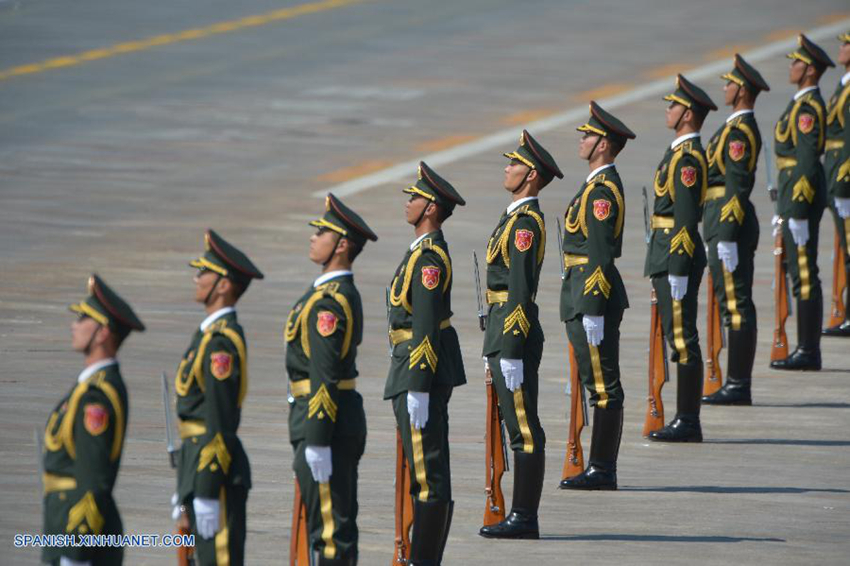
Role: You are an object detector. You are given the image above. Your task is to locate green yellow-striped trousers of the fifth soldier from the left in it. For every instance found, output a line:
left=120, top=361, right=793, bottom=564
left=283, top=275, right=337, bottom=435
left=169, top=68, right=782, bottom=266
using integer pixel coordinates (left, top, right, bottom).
left=487, top=341, right=546, bottom=454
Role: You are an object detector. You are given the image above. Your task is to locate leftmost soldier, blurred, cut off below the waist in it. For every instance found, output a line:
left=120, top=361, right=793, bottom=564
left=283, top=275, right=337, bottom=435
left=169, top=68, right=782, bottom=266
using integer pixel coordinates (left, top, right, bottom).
left=41, top=275, right=145, bottom=566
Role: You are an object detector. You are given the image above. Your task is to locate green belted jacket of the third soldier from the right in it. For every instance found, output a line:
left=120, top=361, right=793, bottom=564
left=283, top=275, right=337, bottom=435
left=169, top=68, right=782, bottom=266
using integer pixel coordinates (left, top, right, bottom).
left=703, top=111, right=762, bottom=242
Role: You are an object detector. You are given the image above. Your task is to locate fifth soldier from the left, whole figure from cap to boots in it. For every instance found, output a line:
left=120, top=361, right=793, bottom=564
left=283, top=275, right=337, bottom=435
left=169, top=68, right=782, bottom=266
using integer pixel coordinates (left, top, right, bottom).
left=479, top=130, right=564, bottom=539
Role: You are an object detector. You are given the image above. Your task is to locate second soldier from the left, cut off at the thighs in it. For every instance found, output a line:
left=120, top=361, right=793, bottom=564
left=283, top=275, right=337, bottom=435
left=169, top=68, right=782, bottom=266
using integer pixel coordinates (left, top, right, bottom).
left=174, top=230, right=263, bottom=566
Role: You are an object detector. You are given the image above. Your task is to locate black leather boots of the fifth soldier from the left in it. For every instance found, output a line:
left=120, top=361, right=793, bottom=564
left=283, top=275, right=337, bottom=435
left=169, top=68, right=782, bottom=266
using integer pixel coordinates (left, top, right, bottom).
left=478, top=452, right=546, bottom=539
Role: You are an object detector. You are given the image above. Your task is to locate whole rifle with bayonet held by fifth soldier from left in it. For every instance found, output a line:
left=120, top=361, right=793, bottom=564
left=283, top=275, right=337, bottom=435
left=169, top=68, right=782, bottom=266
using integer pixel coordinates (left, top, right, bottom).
left=472, top=250, right=508, bottom=526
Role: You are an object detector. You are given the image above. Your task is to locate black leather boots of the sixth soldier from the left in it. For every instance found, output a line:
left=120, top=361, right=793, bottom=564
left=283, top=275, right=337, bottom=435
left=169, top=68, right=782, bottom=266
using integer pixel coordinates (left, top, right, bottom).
left=560, top=407, right=623, bottom=491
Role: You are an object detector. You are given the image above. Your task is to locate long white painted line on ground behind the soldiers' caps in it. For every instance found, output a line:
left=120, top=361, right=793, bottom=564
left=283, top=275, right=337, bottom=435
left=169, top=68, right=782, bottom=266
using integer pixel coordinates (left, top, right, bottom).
left=313, top=18, right=850, bottom=198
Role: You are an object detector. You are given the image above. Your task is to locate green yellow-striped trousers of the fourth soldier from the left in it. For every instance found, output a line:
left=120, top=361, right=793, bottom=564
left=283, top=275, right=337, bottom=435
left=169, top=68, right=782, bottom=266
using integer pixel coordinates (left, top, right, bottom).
left=392, top=385, right=452, bottom=501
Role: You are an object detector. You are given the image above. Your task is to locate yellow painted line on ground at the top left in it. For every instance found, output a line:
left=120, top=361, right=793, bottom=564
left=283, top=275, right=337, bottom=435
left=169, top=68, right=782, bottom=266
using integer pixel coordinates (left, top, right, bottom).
left=0, top=0, right=368, bottom=81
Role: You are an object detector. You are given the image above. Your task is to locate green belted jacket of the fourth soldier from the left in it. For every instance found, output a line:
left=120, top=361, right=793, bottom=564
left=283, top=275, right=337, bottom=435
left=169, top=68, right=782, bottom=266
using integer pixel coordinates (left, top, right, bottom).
left=384, top=230, right=466, bottom=399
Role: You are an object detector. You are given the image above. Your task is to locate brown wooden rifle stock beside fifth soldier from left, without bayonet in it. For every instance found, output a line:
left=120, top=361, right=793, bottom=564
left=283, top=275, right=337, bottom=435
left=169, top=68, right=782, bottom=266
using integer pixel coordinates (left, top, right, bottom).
left=484, top=367, right=507, bottom=527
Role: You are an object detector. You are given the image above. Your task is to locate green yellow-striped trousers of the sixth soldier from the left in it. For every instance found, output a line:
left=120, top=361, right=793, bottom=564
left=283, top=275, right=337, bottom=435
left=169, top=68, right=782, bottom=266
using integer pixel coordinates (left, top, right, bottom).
left=566, top=311, right=625, bottom=409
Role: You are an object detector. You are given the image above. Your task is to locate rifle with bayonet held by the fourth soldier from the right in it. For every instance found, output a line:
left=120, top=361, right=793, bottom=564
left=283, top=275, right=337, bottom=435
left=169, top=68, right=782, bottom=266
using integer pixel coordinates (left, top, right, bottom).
left=643, top=187, right=670, bottom=436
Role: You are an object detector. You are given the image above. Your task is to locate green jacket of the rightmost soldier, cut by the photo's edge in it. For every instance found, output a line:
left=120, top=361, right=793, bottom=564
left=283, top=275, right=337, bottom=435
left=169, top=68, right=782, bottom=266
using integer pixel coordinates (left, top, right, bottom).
left=824, top=75, right=850, bottom=199
